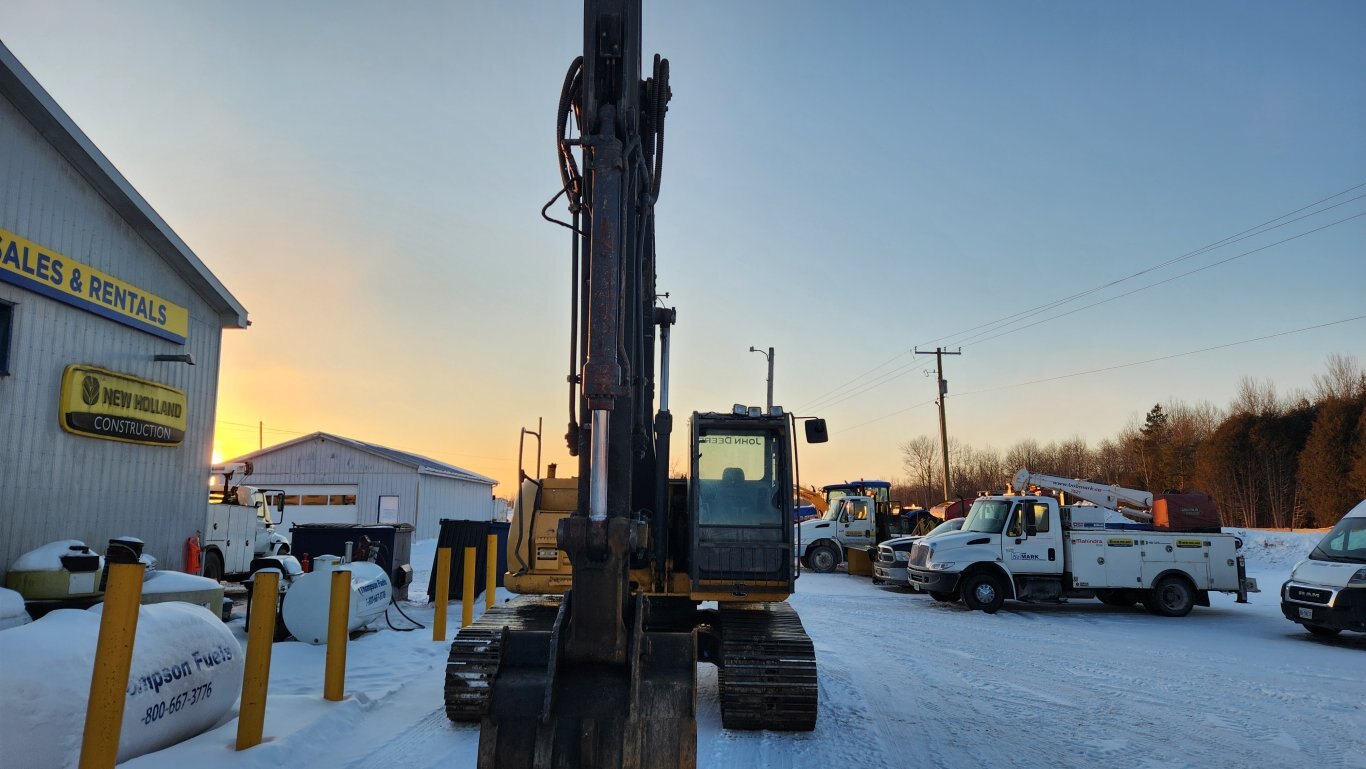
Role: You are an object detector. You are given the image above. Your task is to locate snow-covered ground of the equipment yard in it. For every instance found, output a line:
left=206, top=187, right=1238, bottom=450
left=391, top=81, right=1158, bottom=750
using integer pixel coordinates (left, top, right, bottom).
left=0, top=531, right=1366, bottom=769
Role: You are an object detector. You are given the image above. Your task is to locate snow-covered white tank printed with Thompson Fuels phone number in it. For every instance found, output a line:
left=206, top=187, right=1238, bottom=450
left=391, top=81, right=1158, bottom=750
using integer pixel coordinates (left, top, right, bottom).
left=0, top=602, right=243, bottom=769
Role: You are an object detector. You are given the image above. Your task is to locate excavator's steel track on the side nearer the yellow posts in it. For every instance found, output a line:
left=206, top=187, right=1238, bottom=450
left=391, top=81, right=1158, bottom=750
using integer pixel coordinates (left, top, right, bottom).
left=445, top=596, right=560, bottom=724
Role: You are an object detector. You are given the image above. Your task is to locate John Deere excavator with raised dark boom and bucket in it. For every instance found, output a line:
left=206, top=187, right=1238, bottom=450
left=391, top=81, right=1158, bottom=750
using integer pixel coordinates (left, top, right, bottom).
left=445, top=0, right=825, bottom=769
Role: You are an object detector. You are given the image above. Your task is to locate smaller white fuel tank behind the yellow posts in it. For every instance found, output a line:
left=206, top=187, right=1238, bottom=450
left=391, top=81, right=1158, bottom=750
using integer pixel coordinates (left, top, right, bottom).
left=280, top=556, right=393, bottom=645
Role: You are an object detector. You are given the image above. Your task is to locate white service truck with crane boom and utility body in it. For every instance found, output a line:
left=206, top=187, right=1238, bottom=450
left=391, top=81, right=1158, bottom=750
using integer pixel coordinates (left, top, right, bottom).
left=907, top=470, right=1257, bottom=617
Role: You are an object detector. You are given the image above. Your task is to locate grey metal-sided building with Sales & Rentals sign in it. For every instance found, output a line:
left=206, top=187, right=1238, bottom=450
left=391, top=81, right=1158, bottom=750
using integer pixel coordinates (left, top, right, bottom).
left=0, top=45, right=247, bottom=579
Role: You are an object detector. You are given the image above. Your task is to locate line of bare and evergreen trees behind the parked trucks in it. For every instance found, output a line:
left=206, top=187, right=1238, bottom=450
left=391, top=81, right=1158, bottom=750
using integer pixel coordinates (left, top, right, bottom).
left=892, top=355, right=1366, bottom=529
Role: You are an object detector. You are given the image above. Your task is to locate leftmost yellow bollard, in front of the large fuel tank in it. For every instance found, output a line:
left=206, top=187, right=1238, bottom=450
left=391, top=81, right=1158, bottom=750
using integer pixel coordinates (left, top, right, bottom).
left=79, top=541, right=146, bottom=769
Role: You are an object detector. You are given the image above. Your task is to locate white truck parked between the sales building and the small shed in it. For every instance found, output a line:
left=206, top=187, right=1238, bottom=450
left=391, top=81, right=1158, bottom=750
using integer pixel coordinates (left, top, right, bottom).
left=201, top=462, right=290, bottom=582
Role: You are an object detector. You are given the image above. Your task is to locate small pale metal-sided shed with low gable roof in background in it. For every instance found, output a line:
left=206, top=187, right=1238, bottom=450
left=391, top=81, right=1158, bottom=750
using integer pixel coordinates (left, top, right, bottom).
left=232, top=433, right=497, bottom=540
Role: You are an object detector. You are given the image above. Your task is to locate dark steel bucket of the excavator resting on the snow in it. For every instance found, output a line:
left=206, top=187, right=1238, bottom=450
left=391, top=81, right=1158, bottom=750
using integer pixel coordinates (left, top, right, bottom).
left=479, top=598, right=697, bottom=769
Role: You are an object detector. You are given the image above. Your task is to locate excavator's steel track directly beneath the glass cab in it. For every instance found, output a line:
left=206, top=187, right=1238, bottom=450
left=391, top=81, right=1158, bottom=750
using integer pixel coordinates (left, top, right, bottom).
left=717, top=601, right=817, bottom=732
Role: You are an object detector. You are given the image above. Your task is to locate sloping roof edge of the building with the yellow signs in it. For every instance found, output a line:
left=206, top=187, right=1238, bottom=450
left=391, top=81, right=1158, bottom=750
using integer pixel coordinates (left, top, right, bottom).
left=0, top=42, right=249, bottom=328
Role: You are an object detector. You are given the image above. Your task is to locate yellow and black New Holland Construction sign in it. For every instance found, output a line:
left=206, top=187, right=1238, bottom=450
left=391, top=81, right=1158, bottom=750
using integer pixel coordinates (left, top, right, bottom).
left=60, top=365, right=186, bottom=445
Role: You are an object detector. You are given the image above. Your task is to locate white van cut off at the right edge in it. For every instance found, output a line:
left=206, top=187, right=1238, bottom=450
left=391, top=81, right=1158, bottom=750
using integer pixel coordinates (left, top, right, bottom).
left=1281, top=500, right=1366, bottom=637
